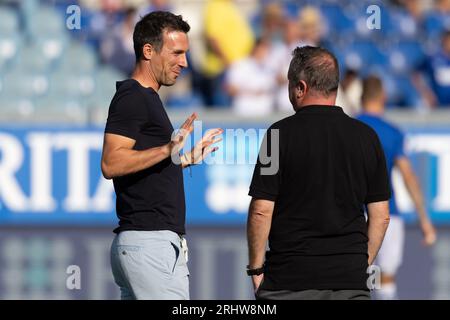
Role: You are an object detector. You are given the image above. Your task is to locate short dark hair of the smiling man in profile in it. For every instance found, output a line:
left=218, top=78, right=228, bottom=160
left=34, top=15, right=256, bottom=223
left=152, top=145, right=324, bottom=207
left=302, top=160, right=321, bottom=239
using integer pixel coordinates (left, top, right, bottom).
left=133, top=11, right=191, bottom=61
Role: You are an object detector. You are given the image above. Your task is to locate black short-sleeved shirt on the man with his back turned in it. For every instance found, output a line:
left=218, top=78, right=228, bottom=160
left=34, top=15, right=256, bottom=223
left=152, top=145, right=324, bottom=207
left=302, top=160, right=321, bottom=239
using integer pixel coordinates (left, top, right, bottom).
left=249, top=106, right=390, bottom=290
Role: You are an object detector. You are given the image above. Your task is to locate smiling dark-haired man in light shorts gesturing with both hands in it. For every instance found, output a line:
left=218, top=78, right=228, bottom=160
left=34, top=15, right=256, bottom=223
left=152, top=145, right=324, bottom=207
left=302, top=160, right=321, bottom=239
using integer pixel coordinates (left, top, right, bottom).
left=101, top=12, right=222, bottom=299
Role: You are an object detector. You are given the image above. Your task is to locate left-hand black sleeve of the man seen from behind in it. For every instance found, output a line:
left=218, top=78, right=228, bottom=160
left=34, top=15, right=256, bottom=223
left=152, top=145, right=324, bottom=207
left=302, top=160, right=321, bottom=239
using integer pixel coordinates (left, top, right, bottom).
left=248, top=128, right=281, bottom=201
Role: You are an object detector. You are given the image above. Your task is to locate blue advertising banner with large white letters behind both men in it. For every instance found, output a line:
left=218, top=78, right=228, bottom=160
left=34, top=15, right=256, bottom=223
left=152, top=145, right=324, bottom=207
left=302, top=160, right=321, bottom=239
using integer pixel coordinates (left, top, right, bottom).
left=0, top=123, right=450, bottom=226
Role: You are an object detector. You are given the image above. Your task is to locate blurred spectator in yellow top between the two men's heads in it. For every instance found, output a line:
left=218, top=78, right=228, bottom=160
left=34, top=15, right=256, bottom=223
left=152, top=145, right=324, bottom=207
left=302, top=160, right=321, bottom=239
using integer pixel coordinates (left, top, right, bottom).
left=199, top=0, right=254, bottom=106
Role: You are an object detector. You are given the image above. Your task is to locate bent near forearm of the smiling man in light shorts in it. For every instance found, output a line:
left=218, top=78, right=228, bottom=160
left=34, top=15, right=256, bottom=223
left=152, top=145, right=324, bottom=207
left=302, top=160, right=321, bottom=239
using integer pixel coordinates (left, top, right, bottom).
left=102, top=144, right=171, bottom=179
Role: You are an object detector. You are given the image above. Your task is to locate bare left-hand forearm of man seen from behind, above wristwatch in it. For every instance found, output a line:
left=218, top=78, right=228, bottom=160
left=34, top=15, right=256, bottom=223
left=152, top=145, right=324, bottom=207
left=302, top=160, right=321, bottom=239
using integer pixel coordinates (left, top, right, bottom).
left=247, top=204, right=272, bottom=269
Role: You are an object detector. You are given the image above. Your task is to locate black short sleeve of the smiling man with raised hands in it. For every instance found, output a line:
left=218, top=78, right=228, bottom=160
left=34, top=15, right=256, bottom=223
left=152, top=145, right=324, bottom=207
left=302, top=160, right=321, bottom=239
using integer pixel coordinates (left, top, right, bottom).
left=105, top=91, right=148, bottom=140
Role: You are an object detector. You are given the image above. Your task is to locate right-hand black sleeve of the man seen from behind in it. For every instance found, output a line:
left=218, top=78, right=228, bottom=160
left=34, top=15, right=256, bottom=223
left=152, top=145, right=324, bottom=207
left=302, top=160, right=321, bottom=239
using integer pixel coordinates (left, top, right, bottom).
left=364, top=133, right=391, bottom=204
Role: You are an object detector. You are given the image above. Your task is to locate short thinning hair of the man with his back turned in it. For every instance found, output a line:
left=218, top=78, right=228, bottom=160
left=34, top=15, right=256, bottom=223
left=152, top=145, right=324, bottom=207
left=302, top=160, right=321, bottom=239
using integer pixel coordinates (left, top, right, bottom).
left=288, top=46, right=339, bottom=97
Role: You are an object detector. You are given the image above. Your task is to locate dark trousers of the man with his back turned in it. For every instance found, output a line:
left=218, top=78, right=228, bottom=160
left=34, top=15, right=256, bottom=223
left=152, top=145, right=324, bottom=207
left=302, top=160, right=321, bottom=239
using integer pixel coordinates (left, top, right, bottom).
left=255, top=290, right=370, bottom=300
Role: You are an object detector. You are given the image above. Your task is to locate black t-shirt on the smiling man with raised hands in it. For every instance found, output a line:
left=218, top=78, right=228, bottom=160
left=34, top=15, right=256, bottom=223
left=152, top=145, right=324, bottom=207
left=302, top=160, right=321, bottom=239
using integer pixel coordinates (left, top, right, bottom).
left=105, top=79, right=185, bottom=234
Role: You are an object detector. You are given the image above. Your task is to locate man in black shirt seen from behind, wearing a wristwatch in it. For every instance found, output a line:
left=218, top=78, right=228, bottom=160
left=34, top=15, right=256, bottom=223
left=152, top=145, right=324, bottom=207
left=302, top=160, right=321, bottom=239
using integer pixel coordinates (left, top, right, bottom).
left=247, top=46, right=390, bottom=299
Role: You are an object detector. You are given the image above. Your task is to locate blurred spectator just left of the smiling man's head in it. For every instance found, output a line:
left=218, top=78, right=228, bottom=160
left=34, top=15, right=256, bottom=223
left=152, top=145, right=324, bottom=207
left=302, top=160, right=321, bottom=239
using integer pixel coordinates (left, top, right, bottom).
left=101, top=8, right=136, bottom=76
